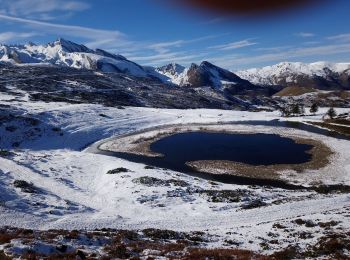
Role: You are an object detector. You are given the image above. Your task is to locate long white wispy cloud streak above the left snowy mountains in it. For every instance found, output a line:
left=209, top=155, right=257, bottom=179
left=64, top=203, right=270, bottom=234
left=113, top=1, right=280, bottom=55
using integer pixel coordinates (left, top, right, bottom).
left=0, top=14, right=221, bottom=67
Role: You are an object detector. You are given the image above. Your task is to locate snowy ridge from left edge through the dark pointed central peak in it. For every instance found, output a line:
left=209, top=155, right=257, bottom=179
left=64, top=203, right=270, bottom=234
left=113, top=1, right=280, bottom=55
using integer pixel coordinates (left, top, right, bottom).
left=0, top=39, right=249, bottom=88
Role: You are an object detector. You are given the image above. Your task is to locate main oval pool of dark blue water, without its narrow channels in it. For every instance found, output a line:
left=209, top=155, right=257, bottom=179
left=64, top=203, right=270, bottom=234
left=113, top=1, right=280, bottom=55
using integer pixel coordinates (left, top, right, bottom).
left=151, top=132, right=312, bottom=166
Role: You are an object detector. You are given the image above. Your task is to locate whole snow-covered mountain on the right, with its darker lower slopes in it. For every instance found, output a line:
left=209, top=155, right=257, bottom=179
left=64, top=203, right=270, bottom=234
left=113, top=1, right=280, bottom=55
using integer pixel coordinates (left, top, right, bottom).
left=236, top=62, right=350, bottom=89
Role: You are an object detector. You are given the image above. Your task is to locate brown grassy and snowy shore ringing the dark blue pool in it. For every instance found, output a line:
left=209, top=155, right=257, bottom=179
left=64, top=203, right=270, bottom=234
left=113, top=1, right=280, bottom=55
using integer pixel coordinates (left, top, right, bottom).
left=99, top=125, right=335, bottom=182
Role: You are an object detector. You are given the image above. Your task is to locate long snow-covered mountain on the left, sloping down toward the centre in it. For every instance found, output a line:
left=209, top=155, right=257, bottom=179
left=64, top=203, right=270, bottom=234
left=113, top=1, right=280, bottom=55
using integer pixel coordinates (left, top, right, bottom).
left=0, top=39, right=148, bottom=77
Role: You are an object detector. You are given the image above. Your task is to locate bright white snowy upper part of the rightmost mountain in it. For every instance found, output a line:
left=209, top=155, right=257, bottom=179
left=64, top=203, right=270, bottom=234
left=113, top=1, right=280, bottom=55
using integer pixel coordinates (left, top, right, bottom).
left=236, top=61, right=350, bottom=85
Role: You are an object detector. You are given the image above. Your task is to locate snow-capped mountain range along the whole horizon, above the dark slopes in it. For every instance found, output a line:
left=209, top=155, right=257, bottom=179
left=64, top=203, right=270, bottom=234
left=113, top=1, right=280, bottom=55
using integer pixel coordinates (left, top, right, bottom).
left=0, top=39, right=350, bottom=92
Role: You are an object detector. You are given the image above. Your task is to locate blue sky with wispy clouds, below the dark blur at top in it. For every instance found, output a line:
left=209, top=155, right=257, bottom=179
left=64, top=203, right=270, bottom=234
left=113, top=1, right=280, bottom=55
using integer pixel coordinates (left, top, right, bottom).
left=0, top=0, right=350, bottom=70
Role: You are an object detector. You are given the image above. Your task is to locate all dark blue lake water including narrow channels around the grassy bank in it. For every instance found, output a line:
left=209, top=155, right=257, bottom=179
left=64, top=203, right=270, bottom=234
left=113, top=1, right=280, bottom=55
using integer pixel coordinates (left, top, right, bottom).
left=99, top=130, right=318, bottom=189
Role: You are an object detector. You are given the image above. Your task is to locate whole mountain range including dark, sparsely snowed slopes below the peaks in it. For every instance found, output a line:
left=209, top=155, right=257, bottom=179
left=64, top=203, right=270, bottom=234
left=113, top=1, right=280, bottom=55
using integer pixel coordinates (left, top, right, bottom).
left=0, top=39, right=350, bottom=109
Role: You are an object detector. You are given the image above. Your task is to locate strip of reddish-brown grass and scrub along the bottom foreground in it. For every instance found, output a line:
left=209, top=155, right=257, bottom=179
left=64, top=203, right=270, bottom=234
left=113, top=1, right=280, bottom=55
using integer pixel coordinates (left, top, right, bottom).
left=0, top=226, right=350, bottom=260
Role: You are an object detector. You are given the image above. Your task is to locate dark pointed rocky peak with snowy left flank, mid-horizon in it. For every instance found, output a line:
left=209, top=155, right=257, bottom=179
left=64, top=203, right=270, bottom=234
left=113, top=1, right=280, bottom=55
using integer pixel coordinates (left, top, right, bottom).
left=156, top=61, right=250, bottom=88
